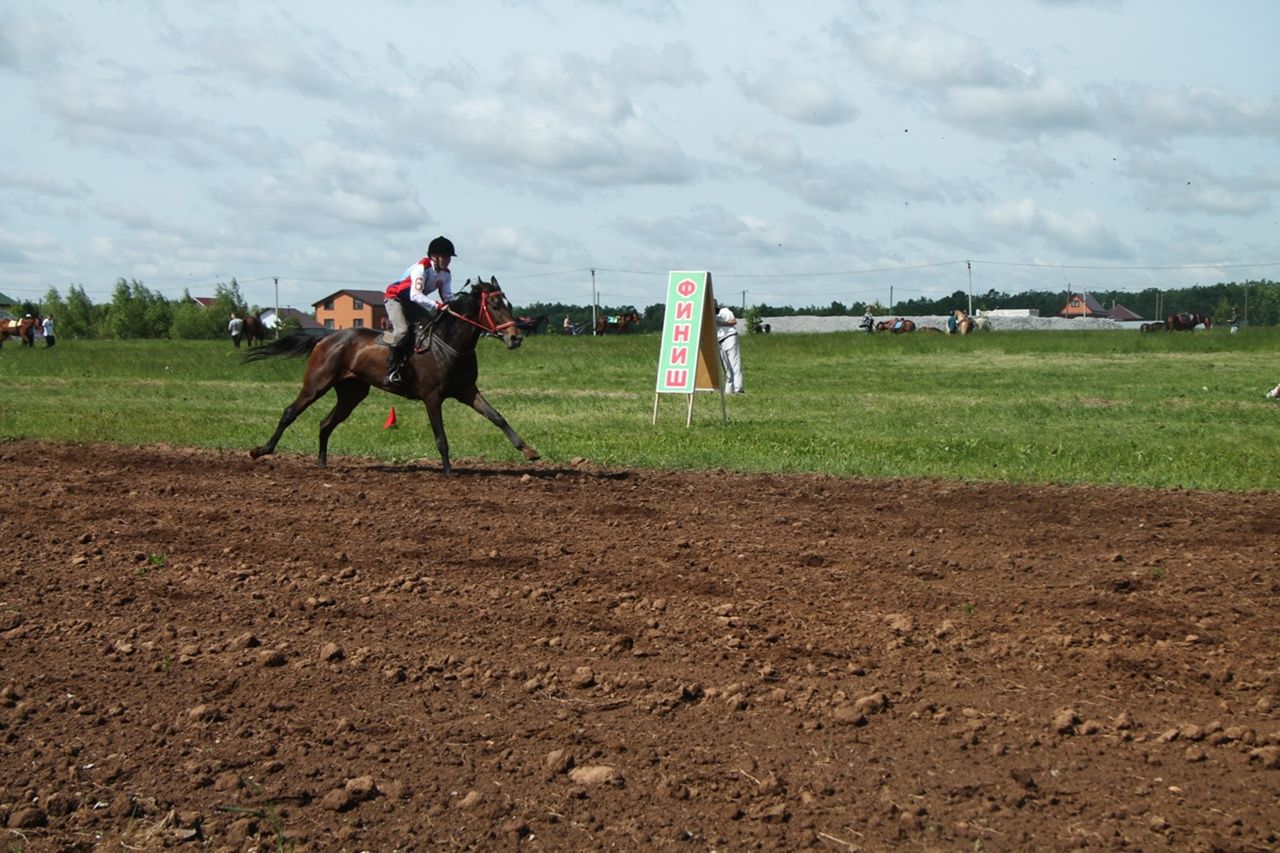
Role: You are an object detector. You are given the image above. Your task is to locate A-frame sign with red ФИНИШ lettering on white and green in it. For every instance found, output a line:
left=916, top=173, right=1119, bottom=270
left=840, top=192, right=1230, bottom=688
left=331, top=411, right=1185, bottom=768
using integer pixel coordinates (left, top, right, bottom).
left=653, top=272, right=727, bottom=427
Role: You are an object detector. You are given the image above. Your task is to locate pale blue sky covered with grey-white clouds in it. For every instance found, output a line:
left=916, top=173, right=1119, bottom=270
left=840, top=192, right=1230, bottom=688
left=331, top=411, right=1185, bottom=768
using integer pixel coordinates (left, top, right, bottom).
left=0, top=0, right=1280, bottom=307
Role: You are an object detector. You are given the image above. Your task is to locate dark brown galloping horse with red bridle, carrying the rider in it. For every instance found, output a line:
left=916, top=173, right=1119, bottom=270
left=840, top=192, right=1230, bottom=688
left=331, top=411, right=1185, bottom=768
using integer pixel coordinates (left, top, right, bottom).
left=243, top=278, right=539, bottom=474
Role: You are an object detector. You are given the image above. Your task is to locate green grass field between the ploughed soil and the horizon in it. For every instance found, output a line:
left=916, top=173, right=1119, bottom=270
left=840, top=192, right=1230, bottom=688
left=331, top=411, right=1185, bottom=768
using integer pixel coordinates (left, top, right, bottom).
left=0, top=328, right=1280, bottom=491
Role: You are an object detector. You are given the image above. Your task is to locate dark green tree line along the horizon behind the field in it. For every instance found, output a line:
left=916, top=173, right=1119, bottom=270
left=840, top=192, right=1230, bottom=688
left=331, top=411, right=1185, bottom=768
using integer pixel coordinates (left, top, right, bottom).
left=22, top=278, right=1280, bottom=339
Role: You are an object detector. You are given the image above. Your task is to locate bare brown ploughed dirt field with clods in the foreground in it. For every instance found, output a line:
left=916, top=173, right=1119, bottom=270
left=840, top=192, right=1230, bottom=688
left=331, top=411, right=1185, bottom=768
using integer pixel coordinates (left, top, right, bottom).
left=0, top=442, right=1280, bottom=850
